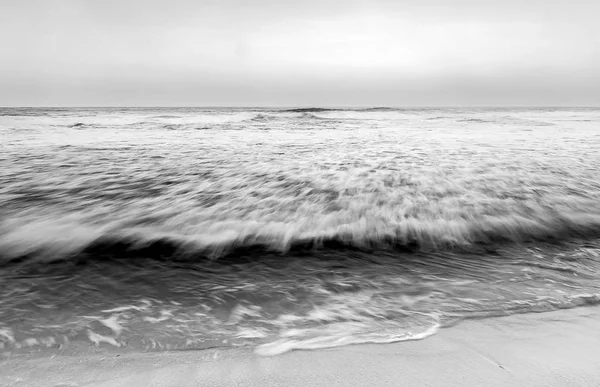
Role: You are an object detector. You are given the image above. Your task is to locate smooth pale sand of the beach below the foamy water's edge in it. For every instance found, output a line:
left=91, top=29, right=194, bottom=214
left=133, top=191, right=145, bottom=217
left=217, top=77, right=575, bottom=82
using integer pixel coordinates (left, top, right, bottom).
left=0, top=307, right=600, bottom=387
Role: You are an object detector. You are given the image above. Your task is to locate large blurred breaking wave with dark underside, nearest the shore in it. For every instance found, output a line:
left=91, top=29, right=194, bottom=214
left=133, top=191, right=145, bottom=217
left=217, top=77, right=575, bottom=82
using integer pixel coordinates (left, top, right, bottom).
left=0, top=209, right=600, bottom=262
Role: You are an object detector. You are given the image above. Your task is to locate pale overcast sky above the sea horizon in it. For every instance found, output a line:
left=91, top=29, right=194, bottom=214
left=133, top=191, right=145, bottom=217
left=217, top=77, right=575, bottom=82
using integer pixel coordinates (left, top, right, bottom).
left=0, top=0, right=600, bottom=107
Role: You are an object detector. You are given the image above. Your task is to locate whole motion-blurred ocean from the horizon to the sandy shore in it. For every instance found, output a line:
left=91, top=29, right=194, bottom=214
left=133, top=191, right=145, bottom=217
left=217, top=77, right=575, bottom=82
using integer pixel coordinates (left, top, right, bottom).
left=0, top=108, right=600, bottom=355
